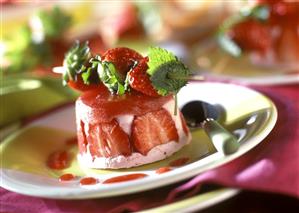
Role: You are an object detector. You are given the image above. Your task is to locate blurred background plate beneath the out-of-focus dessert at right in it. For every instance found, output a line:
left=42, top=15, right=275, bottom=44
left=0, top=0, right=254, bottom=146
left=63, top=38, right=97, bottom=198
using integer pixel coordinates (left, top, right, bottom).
left=191, top=41, right=299, bottom=85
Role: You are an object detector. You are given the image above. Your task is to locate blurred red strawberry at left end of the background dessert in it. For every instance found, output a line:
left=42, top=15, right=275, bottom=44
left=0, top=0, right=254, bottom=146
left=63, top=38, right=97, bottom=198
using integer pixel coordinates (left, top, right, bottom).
left=230, top=20, right=271, bottom=52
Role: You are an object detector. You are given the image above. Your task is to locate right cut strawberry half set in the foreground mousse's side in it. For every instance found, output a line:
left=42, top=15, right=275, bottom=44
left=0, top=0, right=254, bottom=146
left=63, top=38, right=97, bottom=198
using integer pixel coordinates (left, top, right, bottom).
left=131, top=109, right=179, bottom=155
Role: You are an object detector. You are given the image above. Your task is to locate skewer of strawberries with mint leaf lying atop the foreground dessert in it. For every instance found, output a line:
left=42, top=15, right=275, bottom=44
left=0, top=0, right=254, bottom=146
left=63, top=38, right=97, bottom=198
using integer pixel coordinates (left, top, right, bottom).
left=58, top=41, right=190, bottom=113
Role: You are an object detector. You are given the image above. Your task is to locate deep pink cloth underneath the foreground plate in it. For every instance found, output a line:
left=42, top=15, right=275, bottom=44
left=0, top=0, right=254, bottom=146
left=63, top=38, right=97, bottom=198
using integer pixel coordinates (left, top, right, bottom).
left=0, top=85, right=299, bottom=213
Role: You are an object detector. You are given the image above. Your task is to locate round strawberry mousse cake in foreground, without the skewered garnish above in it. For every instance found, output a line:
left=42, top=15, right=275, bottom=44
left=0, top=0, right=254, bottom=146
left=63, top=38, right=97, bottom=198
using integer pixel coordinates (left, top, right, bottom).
left=76, top=85, right=191, bottom=169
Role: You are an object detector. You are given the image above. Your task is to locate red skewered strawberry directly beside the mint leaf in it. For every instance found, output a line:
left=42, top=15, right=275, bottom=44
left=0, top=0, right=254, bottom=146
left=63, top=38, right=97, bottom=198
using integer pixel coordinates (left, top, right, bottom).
left=129, top=58, right=159, bottom=97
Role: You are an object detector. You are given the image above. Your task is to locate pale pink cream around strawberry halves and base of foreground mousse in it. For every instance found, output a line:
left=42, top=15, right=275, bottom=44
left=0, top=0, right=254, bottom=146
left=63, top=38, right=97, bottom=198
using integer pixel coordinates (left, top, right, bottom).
left=77, top=100, right=191, bottom=169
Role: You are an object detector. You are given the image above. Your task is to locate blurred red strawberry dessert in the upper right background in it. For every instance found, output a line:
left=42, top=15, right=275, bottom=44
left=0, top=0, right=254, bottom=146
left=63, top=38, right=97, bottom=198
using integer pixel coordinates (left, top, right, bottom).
left=219, top=0, right=299, bottom=70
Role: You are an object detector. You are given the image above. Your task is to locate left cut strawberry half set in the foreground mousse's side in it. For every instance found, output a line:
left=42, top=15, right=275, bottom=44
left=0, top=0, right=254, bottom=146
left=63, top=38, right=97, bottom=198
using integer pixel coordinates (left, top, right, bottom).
left=87, top=119, right=131, bottom=157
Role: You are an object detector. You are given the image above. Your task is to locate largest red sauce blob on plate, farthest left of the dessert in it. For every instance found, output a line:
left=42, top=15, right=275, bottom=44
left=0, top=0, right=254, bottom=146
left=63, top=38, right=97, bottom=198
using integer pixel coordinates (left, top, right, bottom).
left=47, top=151, right=69, bottom=169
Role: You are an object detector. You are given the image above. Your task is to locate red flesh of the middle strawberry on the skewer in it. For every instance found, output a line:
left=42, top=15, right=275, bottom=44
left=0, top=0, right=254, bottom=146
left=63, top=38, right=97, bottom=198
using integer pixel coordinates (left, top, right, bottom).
left=102, top=47, right=143, bottom=78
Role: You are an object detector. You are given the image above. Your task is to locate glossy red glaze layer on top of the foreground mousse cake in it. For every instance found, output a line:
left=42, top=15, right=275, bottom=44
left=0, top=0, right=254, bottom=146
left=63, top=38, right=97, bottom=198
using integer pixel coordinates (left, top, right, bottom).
left=76, top=86, right=173, bottom=124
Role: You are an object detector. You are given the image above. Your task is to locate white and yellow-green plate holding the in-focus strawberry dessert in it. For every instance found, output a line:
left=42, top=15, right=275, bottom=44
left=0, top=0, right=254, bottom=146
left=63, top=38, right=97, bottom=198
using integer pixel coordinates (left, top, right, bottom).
left=0, top=83, right=277, bottom=199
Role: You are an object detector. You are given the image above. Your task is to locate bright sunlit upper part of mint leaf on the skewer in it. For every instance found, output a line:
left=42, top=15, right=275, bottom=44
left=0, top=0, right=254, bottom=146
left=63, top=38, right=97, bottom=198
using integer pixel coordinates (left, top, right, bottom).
left=147, top=47, right=178, bottom=75
